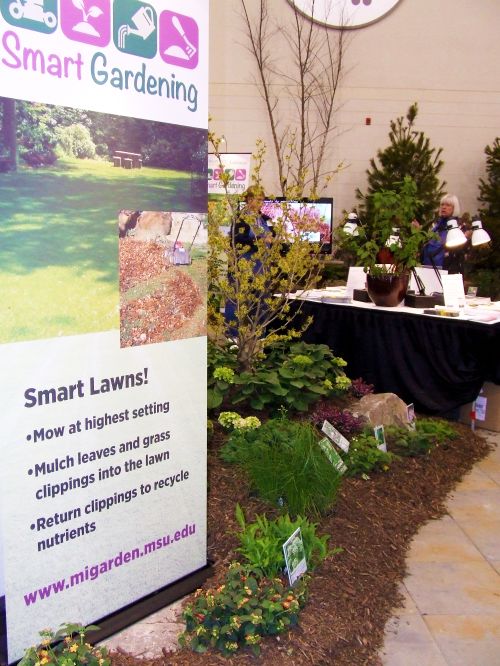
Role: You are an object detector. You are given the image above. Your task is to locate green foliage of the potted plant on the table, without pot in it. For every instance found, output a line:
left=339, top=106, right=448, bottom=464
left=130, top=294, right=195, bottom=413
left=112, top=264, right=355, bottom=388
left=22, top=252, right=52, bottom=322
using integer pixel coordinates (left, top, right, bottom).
left=347, top=176, right=433, bottom=275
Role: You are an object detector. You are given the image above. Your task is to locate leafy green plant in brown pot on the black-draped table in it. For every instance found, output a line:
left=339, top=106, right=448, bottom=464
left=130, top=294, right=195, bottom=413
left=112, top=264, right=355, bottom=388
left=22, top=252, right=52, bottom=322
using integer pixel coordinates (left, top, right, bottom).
left=344, top=176, right=433, bottom=306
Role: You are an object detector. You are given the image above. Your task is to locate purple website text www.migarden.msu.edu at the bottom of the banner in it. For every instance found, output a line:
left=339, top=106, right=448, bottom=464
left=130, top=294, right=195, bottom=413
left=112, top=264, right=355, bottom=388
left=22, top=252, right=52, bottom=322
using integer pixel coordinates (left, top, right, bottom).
left=24, top=523, right=196, bottom=606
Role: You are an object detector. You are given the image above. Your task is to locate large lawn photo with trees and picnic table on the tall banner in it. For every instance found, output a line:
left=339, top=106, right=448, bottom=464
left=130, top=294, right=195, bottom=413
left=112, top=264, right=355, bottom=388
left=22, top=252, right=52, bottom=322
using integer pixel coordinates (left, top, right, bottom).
left=0, top=97, right=207, bottom=343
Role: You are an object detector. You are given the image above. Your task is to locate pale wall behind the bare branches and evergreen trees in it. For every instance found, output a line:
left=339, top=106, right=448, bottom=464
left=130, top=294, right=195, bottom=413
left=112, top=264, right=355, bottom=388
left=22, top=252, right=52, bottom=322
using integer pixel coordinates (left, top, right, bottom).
left=210, top=0, right=500, bottom=223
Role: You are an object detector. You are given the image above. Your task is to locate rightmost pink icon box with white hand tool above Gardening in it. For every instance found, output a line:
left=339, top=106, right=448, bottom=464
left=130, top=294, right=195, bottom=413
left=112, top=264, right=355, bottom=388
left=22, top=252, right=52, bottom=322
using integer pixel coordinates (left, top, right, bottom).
left=159, top=10, right=199, bottom=69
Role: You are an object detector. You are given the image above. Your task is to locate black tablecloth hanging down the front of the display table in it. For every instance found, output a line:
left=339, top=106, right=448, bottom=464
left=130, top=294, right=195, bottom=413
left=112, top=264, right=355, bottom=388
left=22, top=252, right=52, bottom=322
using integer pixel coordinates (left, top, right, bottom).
left=294, top=302, right=500, bottom=414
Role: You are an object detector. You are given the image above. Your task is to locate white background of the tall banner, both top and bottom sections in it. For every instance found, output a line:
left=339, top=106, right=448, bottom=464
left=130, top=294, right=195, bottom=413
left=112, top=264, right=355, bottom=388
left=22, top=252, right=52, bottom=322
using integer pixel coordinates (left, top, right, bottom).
left=0, top=0, right=208, bottom=662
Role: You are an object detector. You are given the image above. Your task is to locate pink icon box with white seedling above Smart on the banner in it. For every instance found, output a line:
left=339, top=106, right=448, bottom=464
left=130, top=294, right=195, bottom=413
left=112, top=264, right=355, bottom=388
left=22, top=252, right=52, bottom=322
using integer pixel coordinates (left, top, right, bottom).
left=60, top=0, right=111, bottom=46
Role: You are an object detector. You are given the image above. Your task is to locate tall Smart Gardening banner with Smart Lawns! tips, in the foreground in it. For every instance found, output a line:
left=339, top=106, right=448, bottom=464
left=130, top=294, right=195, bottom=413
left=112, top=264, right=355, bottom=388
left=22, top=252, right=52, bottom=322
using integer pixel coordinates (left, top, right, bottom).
left=0, top=0, right=208, bottom=662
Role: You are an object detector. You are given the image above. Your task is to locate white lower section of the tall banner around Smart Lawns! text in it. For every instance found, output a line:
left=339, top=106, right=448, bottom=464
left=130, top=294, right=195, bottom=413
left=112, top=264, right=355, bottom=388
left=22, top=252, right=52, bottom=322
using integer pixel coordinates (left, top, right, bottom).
left=0, top=332, right=206, bottom=660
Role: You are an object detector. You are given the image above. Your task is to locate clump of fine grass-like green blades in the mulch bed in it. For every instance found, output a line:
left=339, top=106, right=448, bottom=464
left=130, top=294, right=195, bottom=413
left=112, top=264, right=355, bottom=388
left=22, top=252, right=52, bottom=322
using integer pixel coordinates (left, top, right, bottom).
left=220, top=418, right=342, bottom=517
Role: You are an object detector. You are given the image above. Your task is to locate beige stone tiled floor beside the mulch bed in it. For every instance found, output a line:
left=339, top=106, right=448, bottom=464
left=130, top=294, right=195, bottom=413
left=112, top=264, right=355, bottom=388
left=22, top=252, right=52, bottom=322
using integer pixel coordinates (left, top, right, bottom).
left=381, top=431, right=500, bottom=666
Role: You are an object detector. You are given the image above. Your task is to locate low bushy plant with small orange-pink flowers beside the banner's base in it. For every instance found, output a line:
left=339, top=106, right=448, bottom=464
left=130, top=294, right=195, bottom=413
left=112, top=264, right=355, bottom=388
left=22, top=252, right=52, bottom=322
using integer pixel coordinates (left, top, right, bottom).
left=179, top=562, right=307, bottom=657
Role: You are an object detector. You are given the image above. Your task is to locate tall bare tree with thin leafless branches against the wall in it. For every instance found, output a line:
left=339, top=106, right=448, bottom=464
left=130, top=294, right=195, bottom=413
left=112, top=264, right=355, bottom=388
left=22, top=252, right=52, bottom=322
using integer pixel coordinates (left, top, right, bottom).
left=240, top=0, right=349, bottom=197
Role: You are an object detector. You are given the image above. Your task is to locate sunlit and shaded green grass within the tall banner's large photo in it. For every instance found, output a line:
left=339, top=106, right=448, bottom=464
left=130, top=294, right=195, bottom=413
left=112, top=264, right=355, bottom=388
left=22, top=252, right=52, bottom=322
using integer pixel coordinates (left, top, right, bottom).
left=0, top=158, right=203, bottom=343
